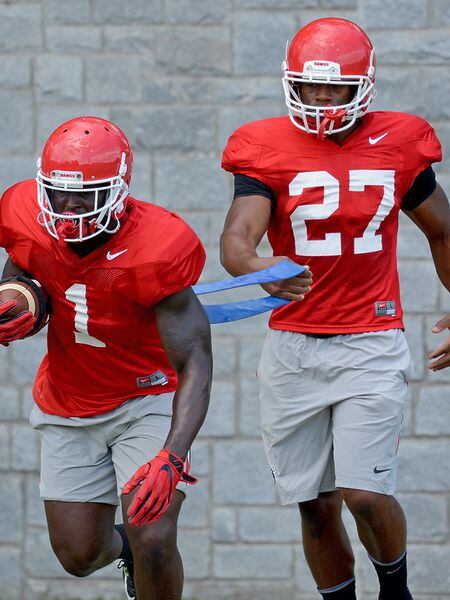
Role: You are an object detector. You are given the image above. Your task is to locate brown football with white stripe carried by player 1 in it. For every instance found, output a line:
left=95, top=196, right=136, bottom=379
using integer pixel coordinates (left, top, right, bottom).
left=0, top=276, right=49, bottom=333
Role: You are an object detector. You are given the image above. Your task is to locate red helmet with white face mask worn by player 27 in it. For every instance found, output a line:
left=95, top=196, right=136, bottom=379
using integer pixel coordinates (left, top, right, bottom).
left=283, top=17, right=375, bottom=138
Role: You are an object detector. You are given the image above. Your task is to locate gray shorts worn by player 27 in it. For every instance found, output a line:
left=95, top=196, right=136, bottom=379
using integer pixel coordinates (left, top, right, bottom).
left=258, top=329, right=411, bottom=504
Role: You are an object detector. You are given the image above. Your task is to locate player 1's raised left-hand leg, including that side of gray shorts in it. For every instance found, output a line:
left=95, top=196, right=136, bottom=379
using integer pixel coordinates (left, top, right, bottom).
left=30, top=406, right=123, bottom=577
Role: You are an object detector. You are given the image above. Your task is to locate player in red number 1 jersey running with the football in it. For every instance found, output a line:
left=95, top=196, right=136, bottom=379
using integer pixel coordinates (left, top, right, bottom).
left=0, top=117, right=211, bottom=600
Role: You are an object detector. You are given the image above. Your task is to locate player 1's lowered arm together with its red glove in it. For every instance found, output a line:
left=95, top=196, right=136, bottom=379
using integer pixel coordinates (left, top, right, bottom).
left=123, top=288, right=212, bottom=525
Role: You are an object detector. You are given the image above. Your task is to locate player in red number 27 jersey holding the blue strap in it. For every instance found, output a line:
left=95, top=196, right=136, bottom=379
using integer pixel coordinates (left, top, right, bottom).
left=221, top=18, right=450, bottom=600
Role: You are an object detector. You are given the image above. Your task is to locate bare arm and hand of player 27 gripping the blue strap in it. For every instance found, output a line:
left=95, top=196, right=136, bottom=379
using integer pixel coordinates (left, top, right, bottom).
left=220, top=196, right=312, bottom=300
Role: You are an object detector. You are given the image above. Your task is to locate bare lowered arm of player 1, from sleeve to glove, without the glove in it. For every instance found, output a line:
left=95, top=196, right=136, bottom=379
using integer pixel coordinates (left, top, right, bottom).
left=153, top=288, right=212, bottom=459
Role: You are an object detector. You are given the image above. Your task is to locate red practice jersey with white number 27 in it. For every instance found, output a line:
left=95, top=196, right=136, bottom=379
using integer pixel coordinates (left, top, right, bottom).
left=222, top=112, right=441, bottom=334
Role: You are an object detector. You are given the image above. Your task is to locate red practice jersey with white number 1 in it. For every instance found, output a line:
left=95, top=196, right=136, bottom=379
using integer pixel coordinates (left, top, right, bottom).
left=0, top=180, right=205, bottom=417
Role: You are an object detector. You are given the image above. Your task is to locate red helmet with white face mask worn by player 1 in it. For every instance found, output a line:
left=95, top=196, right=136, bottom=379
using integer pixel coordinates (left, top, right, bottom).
left=36, top=117, right=133, bottom=242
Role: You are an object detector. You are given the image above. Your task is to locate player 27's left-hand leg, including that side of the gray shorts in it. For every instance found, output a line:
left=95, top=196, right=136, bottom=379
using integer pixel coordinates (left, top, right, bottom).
left=258, top=331, right=355, bottom=600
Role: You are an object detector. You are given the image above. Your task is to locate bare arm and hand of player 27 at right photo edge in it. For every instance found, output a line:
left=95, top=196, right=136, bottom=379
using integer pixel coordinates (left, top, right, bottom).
left=405, top=185, right=450, bottom=371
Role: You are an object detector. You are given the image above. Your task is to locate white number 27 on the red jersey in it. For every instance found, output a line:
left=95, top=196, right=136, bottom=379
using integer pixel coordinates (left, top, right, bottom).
left=289, top=169, right=395, bottom=256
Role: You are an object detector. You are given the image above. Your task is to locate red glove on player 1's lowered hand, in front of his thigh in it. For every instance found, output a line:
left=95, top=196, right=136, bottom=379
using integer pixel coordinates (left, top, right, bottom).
left=122, top=449, right=197, bottom=525
